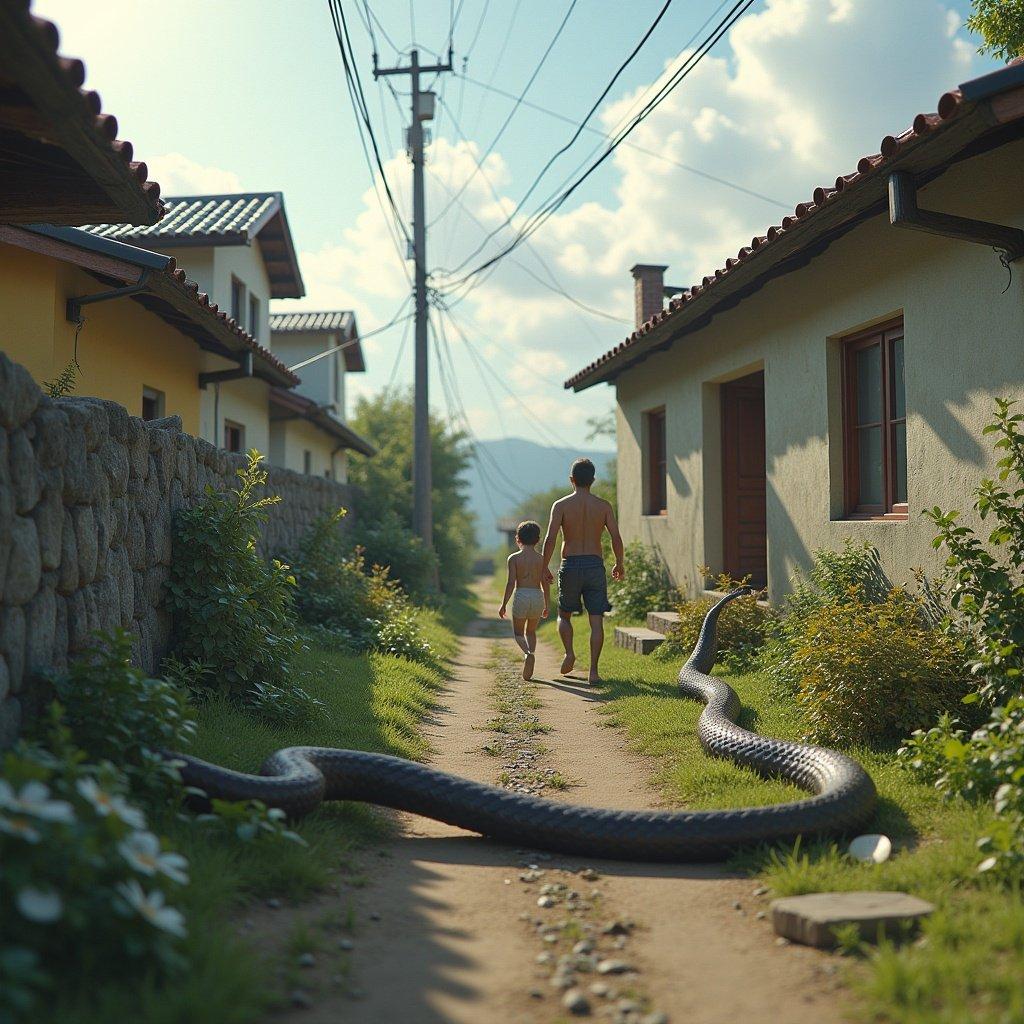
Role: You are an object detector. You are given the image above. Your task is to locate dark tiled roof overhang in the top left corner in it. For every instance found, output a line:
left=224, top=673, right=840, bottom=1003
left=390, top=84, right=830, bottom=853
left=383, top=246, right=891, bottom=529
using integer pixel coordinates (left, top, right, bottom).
left=0, top=0, right=163, bottom=224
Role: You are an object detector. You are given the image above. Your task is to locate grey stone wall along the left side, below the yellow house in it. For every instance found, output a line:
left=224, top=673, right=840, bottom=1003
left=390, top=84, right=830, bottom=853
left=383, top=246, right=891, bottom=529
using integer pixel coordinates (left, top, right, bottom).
left=0, top=353, right=355, bottom=749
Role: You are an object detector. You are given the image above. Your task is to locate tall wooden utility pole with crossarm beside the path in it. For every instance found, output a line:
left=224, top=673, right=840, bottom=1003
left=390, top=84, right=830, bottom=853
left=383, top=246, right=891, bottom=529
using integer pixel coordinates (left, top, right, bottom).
left=374, top=49, right=452, bottom=548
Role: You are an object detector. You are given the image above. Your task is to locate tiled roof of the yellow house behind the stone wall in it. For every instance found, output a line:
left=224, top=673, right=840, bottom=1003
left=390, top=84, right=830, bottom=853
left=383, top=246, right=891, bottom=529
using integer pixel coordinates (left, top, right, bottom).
left=12, top=224, right=299, bottom=387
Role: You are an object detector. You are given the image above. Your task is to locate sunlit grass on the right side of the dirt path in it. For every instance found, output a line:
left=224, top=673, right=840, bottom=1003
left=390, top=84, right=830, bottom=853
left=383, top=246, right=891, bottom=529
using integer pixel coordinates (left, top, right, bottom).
left=549, top=626, right=1024, bottom=1024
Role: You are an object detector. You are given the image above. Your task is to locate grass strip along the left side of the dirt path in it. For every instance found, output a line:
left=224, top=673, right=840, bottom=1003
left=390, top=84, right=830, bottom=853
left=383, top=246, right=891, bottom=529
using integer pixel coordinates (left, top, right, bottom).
left=50, top=600, right=462, bottom=1024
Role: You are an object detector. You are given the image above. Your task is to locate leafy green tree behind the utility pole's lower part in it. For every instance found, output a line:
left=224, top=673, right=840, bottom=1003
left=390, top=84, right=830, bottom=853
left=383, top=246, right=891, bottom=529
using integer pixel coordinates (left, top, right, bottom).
left=349, top=388, right=473, bottom=593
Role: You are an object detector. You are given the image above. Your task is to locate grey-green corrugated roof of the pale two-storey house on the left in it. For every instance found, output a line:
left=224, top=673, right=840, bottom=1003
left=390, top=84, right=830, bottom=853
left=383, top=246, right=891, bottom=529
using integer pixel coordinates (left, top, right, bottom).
left=85, top=191, right=305, bottom=299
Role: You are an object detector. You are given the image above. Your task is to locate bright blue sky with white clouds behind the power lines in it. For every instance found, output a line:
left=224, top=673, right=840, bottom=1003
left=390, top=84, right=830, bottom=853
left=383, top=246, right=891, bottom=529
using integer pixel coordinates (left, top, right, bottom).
left=34, top=0, right=995, bottom=446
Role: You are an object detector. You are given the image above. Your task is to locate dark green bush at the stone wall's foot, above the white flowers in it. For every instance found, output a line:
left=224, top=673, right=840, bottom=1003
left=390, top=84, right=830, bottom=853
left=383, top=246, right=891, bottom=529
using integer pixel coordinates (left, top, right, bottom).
left=43, top=629, right=196, bottom=804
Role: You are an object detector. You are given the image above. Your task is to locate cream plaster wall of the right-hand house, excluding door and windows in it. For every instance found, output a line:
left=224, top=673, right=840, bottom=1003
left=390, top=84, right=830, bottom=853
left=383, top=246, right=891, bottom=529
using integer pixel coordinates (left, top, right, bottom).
left=615, top=142, right=1024, bottom=599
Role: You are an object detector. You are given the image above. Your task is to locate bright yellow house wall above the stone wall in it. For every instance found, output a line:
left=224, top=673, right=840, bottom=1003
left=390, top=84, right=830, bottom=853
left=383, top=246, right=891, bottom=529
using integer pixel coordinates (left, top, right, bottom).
left=0, top=244, right=203, bottom=433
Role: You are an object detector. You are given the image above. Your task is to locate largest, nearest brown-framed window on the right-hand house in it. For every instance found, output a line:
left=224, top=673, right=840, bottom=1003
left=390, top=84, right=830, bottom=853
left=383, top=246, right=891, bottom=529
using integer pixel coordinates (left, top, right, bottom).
left=843, top=321, right=907, bottom=519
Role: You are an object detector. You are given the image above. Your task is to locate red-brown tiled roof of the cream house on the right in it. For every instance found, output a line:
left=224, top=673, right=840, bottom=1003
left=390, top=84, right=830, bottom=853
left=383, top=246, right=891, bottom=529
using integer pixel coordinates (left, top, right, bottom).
left=564, top=61, right=1024, bottom=391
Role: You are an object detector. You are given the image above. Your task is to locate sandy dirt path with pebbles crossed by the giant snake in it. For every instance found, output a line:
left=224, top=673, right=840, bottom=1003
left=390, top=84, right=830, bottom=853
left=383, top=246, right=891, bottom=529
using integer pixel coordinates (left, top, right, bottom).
left=276, top=593, right=842, bottom=1024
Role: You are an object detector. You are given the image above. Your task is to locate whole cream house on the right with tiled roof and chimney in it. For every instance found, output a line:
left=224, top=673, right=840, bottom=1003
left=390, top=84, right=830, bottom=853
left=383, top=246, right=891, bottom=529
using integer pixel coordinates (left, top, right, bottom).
left=566, top=65, right=1024, bottom=599
